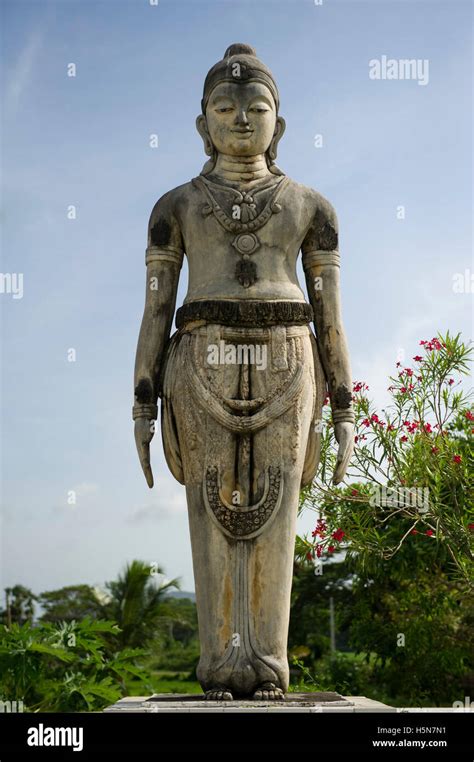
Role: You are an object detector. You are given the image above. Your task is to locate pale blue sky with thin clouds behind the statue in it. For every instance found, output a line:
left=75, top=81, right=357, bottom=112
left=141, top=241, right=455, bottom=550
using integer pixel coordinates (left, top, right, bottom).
left=0, top=0, right=473, bottom=592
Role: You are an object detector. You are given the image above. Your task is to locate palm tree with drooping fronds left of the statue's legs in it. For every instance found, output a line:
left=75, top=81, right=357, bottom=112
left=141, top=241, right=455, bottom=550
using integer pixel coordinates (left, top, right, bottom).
left=106, top=560, right=179, bottom=648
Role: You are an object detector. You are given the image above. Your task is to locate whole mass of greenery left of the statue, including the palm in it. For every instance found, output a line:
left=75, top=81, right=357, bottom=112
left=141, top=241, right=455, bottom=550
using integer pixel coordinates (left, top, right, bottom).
left=0, top=561, right=199, bottom=712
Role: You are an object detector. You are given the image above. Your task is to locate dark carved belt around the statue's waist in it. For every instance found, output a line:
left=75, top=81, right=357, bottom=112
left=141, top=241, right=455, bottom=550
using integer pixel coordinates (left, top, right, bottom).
left=176, top=300, right=313, bottom=330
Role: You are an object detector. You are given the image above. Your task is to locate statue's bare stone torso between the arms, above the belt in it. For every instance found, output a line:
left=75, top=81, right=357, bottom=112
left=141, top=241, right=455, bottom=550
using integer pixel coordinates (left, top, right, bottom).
left=166, top=176, right=319, bottom=302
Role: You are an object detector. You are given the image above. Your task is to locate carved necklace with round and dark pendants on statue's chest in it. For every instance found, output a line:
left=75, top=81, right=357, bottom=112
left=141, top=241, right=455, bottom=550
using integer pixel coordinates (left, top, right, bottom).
left=193, top=175, right=289, bottom=288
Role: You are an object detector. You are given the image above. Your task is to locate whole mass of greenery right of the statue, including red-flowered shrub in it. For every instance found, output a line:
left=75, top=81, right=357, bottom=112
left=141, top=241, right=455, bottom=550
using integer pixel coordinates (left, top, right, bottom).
left=292, top=333, right=474, bottom=705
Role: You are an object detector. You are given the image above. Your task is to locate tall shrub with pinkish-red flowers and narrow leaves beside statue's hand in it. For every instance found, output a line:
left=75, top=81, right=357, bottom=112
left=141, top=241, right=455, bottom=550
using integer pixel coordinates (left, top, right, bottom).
left=296, top=333, right=474, bottom=586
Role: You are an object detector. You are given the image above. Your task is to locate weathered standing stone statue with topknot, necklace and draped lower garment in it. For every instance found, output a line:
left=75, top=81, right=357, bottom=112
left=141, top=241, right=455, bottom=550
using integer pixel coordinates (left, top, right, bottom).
left=133, top=44, right=354, bottom=700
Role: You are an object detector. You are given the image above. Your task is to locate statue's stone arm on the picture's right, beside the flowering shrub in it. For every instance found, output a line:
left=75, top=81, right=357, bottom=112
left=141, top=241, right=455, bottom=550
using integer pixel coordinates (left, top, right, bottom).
left=301, top=196, right=355, bottom=484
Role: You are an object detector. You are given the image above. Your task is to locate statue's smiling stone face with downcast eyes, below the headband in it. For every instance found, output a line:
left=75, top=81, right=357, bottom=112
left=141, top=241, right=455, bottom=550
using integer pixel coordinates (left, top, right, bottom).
left=206, top=82, right=277, bottom=156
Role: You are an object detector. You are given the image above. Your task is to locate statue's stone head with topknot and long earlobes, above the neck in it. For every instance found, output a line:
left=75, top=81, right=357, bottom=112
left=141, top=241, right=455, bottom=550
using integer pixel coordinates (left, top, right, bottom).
left=196, top=43, right=285, bottom=174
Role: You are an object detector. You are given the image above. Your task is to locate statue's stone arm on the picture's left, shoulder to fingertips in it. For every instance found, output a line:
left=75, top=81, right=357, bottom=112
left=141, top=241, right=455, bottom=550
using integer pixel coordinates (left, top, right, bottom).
left=133, top=194, right=183, bottom=487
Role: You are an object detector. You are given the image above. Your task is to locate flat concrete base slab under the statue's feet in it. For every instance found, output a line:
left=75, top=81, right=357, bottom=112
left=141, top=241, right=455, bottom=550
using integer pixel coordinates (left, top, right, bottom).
left=104, top=692, right=397, bottom=714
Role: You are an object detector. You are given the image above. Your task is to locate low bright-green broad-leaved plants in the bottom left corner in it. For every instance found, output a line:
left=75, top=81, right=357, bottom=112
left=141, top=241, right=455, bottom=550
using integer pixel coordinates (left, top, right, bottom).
left=0, top=617, right=149, bottom=712
